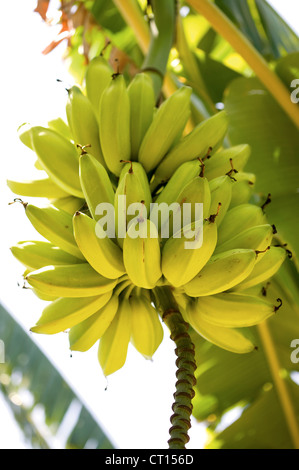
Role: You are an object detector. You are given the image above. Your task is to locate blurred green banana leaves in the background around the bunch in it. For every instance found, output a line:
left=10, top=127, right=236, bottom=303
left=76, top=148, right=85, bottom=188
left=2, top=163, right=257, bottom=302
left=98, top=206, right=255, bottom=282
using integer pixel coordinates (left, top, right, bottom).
left=0, top=0, right=299, bottom=449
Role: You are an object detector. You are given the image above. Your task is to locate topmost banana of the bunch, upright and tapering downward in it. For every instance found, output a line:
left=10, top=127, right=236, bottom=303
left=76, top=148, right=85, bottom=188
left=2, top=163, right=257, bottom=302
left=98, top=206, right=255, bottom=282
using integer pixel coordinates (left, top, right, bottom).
left=85, top=55, right=113, bottom=118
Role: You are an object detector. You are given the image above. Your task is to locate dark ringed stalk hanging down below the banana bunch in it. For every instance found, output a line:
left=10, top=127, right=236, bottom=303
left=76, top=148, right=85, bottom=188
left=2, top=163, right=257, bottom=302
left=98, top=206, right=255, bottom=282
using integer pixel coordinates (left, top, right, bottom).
left=154, top=287, right=196, bottom=449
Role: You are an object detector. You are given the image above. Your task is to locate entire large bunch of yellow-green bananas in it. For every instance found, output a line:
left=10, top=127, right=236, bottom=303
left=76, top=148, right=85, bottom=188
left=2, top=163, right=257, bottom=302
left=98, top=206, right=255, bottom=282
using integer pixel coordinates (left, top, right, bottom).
left=7, top=57, right=287, bottom=375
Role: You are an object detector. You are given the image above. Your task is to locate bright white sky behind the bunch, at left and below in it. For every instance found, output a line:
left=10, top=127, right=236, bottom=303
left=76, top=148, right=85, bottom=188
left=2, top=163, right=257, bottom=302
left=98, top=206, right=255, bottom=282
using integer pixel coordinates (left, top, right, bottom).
left=0, top=0, right=299, bottom=449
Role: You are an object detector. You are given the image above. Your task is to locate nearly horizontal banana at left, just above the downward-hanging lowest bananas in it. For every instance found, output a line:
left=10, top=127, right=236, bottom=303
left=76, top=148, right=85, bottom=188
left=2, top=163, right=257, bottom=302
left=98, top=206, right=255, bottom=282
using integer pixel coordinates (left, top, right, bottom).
left=25, top=263, right=117, bottom=297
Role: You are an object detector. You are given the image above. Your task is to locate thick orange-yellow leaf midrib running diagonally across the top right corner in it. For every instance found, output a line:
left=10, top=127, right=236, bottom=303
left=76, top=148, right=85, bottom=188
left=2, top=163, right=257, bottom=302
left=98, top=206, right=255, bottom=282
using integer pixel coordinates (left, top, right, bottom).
left=187, top=0, right=299, bottom=128
